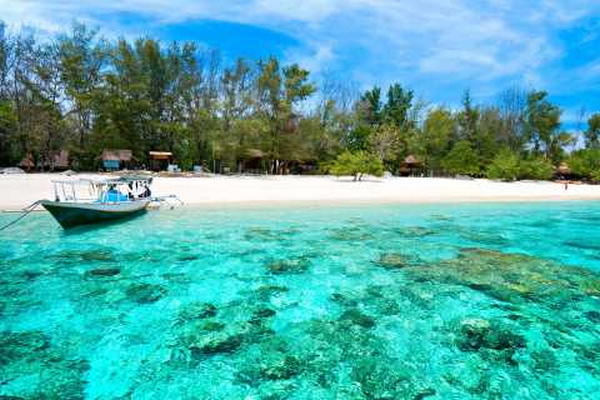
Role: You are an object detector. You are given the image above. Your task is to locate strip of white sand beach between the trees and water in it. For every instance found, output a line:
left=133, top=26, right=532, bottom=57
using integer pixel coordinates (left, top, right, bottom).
left=0, top=174, right=600, bottom=210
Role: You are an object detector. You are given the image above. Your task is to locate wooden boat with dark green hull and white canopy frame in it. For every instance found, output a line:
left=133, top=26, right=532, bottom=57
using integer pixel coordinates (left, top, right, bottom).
left=40, top=178, right=152, bottom=229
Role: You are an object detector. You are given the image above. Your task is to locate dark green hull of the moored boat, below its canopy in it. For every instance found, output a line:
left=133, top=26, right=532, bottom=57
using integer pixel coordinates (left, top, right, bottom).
left=40, top=200, right=150, bottom=229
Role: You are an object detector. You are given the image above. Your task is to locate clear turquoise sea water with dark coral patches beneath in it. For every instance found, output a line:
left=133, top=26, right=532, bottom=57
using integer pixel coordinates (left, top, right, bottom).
left=0, top=202, right=600, bottom=400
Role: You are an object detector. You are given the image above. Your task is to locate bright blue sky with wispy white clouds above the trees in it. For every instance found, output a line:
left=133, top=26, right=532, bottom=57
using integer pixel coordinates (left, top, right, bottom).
left=0, top=0, right=600, bottom=129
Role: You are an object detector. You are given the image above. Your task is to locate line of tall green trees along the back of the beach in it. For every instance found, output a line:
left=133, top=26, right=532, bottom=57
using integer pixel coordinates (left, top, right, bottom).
left=0, top=23, right=600, bottom=181
